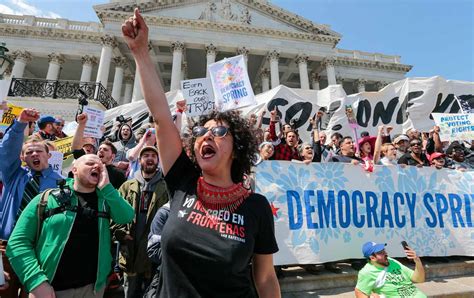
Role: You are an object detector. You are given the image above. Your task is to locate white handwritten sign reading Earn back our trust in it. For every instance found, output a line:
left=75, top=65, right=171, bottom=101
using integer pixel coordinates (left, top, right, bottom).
left=181, top=78, right=214, bottom=117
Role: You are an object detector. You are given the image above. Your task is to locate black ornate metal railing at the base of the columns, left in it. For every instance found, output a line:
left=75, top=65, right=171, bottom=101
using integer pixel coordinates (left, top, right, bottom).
left=8, top=78, right=117, bottom=109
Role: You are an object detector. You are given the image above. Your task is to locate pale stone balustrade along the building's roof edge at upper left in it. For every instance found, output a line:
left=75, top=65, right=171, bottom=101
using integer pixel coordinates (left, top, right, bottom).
left=0, top=13, right=102, bottom=32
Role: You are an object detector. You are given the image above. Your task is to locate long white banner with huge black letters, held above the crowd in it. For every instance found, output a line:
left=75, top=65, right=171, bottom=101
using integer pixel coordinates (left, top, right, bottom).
left=106, top=77, right=474, bottom=144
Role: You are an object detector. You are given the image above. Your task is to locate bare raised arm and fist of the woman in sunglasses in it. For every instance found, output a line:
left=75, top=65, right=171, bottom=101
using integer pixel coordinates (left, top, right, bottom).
left=122, top=8, right=182, bottom=175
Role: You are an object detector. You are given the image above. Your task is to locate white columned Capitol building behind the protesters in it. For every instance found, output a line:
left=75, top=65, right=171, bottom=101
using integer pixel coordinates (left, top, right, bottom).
left=0, top=0, right=411, bottom=119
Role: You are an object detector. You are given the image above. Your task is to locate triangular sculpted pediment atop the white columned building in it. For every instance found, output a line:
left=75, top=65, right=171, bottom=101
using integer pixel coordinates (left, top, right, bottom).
left=94, top=0, right=341, bottom=39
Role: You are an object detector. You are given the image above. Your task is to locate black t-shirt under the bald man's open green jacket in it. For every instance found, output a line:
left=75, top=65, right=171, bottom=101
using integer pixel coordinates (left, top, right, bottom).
left=51, top=191, right=99, bottom=291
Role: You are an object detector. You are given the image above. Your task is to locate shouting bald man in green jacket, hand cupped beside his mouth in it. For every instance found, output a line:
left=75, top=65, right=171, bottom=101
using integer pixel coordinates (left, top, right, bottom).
left=7, top=154, right=133, bottom=297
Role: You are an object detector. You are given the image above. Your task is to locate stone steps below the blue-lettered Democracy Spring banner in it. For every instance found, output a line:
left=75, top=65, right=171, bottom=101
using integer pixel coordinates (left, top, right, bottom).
left=279, top=257, right=474, bottom=298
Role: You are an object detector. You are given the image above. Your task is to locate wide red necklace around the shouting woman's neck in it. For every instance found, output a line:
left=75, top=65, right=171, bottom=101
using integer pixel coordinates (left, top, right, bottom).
left=197, top=177, right=252, bottom=213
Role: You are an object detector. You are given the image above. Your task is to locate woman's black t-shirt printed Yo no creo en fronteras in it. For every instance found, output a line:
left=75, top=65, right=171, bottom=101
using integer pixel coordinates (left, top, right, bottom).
left=158, top=151, right=278, bottom=298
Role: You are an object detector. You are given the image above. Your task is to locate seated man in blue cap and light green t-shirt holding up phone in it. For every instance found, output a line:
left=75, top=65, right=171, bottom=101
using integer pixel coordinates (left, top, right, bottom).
left=355, top=241, right=426, bottom=298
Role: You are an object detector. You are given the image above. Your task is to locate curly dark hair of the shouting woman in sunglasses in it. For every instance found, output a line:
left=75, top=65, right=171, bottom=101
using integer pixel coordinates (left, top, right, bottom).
left=186, top=111, right=258, bottom=183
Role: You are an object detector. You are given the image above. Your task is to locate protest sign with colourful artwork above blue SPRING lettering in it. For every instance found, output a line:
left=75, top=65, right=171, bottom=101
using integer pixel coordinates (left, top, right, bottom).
left=209, top=55, right=256, bottom=111
